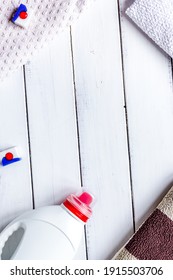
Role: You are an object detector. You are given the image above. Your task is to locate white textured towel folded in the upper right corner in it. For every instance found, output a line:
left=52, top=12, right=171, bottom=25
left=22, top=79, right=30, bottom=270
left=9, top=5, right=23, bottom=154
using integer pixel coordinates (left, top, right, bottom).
left=126, top=0, right=173, bottom=57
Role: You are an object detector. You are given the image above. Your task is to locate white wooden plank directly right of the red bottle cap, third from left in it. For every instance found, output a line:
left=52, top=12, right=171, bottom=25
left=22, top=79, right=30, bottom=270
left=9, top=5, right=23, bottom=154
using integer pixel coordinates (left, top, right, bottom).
left=72, top=0, right=133, bottom=259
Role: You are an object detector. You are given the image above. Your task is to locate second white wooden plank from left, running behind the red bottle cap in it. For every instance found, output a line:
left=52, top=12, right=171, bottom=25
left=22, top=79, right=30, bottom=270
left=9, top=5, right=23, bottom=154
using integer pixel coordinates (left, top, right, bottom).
left=26, top=31, right=85, bottom=259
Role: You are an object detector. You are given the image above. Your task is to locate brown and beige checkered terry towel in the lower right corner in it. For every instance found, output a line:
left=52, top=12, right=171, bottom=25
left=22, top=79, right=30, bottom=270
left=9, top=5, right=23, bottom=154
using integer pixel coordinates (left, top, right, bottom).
left=113, top=187, right=173, bottom=260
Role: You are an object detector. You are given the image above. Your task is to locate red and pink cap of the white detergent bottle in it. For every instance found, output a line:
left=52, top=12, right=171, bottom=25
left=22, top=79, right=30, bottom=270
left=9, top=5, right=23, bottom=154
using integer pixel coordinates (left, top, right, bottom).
left=63, top=192, right=93, bottom=223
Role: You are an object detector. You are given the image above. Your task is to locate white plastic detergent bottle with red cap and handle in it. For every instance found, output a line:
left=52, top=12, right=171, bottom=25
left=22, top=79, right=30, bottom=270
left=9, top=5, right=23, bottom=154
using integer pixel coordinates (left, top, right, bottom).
left=0, top=192, right=93, bottom=260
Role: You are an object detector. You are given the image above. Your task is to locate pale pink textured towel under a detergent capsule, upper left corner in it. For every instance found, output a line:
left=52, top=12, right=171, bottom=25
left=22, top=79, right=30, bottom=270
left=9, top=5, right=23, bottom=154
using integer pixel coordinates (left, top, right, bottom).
left=0, top=0, right=93, bottom=80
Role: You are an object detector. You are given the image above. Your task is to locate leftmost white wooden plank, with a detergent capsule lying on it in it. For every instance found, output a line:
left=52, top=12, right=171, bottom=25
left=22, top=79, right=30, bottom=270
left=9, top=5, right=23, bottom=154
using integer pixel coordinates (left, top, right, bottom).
left=0, top=69, right=32, bottom=230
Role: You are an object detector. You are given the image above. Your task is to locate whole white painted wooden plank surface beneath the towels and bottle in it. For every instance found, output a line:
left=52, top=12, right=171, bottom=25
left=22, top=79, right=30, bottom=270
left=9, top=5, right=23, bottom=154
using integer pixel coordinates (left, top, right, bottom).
left=0, top=0, right=173, bottom=259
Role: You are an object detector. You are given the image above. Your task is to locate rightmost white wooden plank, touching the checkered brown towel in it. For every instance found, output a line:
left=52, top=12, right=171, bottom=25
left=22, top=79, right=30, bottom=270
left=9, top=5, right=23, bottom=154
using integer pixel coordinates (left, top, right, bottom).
left=119, top=0, right=173, bottom=227
